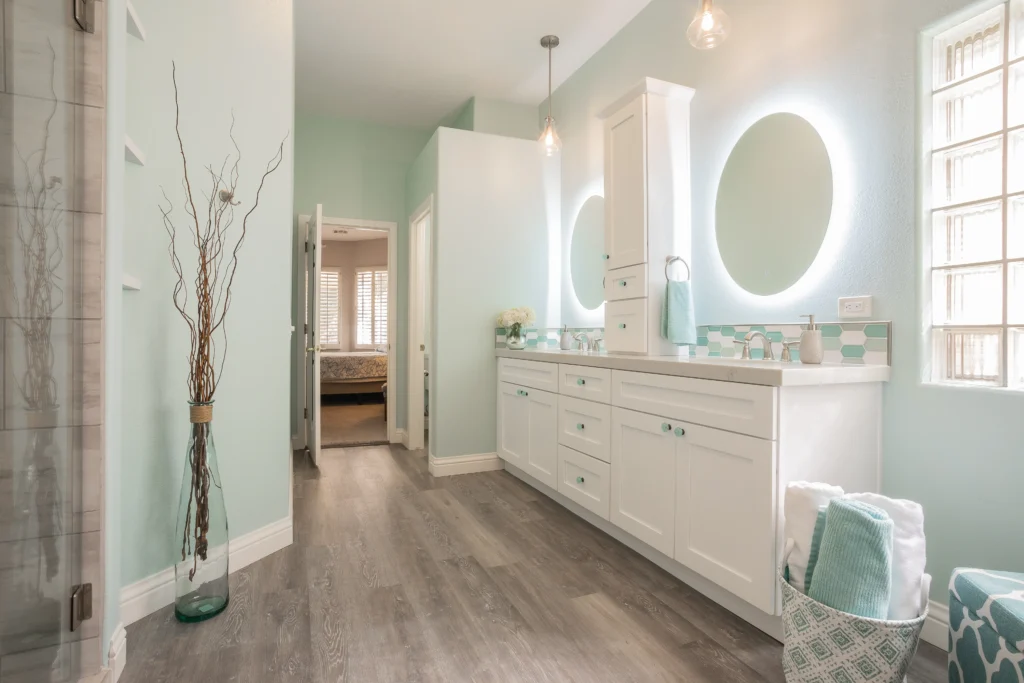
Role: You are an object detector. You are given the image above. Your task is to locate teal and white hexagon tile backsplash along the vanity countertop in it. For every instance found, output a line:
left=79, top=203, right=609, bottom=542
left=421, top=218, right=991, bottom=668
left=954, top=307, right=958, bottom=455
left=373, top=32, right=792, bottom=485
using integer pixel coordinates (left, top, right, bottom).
left=495, top=321, right=892, bottom=366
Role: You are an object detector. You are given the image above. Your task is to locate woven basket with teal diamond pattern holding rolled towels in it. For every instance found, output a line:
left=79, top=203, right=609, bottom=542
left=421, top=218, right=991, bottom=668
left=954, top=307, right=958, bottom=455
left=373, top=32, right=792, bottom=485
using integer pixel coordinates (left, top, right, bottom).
left=778, top=572, right=928, bottom=683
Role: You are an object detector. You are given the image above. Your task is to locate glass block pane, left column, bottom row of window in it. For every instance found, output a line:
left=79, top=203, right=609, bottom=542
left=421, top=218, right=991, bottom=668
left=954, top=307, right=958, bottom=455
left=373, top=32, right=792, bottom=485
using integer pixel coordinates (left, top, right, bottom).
left=932, top=330, right=1002, bottom=386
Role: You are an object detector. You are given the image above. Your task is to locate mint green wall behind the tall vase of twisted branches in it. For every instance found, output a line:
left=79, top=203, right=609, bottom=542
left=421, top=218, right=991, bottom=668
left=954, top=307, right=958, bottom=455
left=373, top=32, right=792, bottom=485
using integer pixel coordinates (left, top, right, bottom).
left=122, top=0, right=295, bottom=585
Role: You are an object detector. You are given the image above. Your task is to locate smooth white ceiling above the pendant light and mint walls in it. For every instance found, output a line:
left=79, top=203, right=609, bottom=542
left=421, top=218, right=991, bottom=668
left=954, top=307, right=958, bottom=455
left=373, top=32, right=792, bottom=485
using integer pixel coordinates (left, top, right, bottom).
left=295, top=0, right=650, bottom=128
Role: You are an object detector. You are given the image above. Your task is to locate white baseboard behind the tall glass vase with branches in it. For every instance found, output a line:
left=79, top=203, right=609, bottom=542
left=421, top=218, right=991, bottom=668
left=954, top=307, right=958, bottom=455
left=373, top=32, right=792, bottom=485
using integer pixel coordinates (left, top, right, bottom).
left=121, top=517, right=293, bottom=625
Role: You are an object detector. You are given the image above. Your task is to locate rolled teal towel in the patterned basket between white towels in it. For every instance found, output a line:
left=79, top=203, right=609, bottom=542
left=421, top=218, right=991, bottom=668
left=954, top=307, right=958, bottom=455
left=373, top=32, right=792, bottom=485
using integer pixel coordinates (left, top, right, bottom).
left=807, top=499, right=893, bottom=618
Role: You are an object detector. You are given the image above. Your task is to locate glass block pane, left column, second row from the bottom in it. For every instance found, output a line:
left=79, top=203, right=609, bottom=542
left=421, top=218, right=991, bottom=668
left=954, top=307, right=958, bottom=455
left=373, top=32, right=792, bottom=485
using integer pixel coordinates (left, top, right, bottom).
left=932, top=265, right=1002, bottom=325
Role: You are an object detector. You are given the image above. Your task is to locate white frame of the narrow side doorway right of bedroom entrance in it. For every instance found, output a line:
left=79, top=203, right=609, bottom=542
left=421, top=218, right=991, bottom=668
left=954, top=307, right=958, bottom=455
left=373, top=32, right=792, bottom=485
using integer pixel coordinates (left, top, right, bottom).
left=403, top=193, right=434, bottom=451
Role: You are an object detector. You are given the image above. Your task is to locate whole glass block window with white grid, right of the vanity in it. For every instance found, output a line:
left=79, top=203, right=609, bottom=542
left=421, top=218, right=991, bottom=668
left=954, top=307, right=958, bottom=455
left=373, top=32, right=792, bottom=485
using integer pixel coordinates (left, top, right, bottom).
left=927, top=0, right=1024, bottom=389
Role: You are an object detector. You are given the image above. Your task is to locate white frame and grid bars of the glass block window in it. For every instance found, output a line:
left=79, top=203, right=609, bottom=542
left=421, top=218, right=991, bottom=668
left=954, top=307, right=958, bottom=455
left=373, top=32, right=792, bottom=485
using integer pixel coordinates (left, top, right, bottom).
left=920, top=0, right=1024, bottom=390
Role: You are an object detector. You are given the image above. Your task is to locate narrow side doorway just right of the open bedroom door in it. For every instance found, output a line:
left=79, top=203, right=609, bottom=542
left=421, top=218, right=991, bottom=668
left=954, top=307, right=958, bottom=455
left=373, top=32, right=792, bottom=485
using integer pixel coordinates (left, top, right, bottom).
left=406, top=195, right=434, bottom=451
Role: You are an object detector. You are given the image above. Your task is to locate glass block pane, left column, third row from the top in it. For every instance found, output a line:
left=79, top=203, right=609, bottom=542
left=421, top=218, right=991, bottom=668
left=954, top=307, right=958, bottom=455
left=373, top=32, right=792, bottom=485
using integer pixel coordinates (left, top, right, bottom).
left=932, top=135, right=1002, bottom=207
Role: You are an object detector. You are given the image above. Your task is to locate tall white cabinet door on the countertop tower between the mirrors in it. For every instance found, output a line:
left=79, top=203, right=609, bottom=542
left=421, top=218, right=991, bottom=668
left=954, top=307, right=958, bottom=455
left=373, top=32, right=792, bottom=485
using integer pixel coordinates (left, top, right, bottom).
left=604, top=95, right=647, bottom=269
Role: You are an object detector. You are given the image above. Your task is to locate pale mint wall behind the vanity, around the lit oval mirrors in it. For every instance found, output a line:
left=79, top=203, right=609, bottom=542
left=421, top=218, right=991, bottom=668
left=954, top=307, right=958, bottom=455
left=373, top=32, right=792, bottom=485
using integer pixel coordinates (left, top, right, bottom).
left=552, top=0, right=1024, bottom=603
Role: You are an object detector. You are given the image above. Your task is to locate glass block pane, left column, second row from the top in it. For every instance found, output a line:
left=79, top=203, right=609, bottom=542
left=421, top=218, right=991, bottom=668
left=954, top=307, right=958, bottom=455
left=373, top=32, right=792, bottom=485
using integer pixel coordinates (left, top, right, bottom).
left=932, top=72, right=1002, bottom=147
